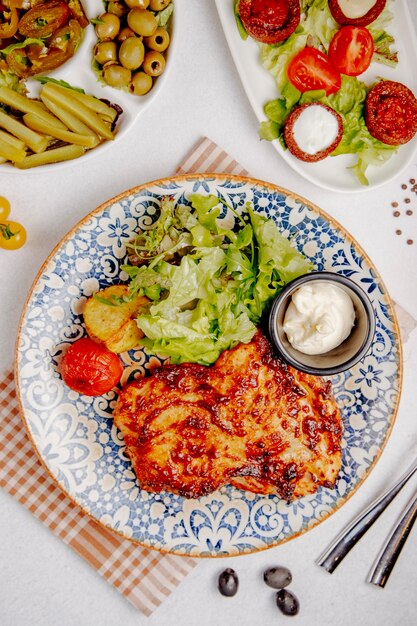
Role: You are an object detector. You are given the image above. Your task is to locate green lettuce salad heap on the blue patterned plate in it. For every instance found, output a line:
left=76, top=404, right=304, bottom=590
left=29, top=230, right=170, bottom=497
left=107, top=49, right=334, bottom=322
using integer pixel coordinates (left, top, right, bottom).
left=122, top=193, right=313, bottom=365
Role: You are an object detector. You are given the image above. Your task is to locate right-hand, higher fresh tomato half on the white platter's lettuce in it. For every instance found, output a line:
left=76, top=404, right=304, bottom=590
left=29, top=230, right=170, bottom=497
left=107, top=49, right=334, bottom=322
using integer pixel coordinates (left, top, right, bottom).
left=329, top=26, right=374, bottom=76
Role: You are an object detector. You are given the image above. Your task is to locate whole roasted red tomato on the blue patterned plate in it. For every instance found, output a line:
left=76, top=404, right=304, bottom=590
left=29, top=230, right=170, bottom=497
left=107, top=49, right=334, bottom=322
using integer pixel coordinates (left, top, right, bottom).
left=61, top=337, right=123, bottom=396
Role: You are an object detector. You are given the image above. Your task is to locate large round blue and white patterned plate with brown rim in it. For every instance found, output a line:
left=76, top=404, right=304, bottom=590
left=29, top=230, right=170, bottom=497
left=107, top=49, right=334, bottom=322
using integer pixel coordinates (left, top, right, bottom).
left=16, top=174, right=402, bottom=556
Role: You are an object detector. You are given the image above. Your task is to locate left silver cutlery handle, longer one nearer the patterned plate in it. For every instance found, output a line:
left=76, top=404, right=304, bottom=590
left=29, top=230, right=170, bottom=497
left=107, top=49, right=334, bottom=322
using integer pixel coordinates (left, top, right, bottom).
left=317, top=459, right=417, bottom=574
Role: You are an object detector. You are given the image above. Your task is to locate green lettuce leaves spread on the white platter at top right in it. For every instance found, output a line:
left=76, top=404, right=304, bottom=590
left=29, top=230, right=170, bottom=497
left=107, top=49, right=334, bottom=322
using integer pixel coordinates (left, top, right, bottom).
left=237, top=0, right=398, bottom=185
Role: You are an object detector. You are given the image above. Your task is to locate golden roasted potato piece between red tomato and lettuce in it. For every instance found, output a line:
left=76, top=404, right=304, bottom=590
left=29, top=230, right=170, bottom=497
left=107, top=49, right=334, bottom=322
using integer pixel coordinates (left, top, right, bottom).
left=84, top=285, right=149, bottom=353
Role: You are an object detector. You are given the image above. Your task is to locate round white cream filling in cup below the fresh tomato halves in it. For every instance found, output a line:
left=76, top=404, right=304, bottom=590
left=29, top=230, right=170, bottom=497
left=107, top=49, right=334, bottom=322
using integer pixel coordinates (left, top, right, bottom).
left=292, top=106, right=339, bottom=154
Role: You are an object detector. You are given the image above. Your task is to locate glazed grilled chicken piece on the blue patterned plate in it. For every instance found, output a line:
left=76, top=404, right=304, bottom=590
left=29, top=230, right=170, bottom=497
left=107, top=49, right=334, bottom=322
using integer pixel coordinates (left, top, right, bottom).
left=114, top=331, right=342, bottom=500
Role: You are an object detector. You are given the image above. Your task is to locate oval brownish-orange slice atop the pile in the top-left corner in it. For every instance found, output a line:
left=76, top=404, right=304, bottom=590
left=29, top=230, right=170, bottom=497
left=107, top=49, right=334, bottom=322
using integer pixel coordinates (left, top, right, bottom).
left=19, top=0, right=71, bottom=39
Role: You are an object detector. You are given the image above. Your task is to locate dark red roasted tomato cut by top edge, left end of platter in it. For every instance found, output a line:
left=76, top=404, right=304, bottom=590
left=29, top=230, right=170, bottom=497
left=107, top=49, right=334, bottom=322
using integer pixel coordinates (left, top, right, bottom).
left=238, top=0, right=300, bottom=44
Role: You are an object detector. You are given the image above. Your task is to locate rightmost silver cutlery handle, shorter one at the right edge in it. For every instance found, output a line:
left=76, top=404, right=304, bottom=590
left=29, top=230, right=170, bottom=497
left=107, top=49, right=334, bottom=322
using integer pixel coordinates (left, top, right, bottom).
left=368, top=494, right=417, bottom=587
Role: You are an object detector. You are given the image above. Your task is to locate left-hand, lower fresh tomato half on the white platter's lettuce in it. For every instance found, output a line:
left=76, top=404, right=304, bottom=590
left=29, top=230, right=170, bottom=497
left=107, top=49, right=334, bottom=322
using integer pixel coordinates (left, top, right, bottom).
left=287, top=46, right=342, bottom=95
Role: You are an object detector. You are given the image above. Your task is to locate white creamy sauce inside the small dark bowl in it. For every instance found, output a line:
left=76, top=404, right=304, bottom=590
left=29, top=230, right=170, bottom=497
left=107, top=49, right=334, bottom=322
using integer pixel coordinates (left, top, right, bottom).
left=283, top=282, right=355, bottom=355
